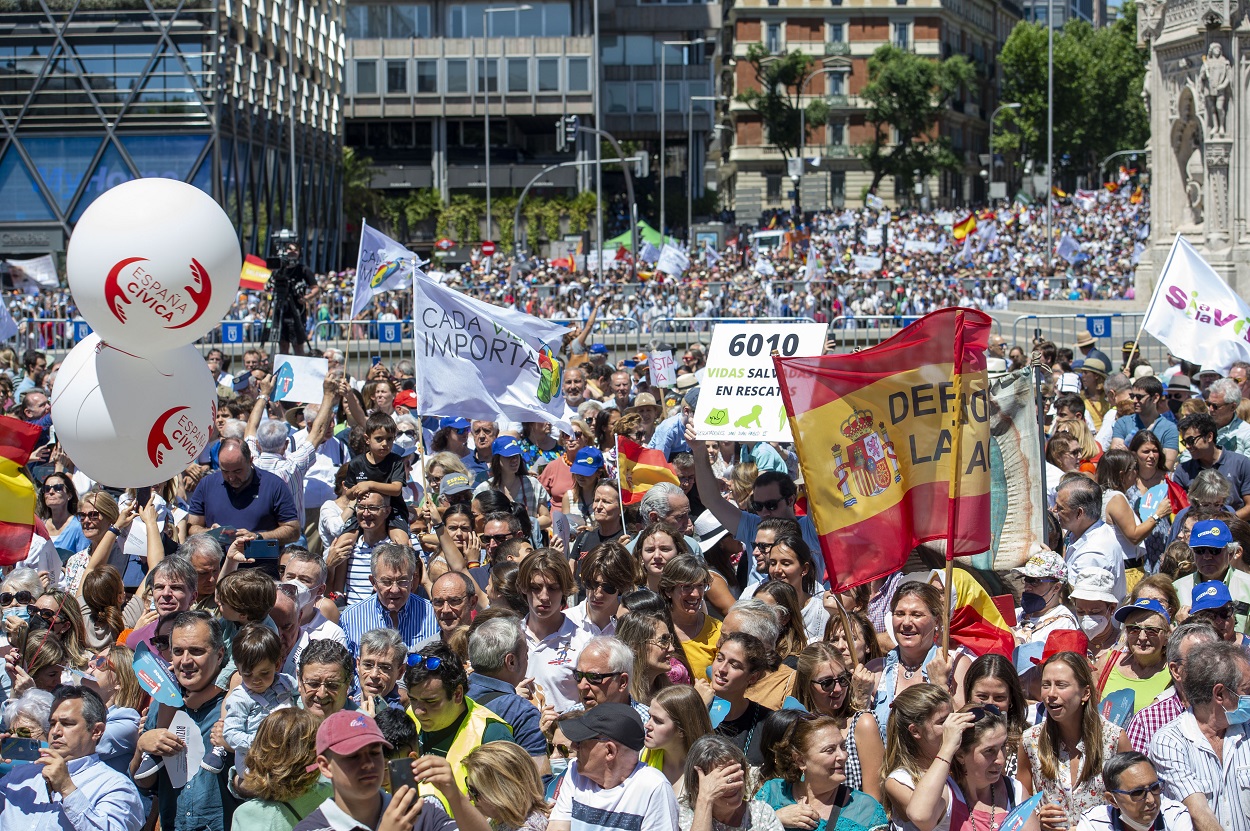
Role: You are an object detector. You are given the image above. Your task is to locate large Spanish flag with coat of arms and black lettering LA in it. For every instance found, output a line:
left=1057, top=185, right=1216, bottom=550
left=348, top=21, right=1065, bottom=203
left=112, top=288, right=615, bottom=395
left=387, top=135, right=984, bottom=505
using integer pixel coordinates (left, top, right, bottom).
left=774, top=309, right=993, bottom=591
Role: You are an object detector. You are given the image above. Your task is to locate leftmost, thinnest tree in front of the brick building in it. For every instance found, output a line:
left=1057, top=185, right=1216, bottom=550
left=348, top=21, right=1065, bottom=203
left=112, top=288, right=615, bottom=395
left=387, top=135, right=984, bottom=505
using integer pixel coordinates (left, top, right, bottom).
left=730, top=44, right=829, bottom=162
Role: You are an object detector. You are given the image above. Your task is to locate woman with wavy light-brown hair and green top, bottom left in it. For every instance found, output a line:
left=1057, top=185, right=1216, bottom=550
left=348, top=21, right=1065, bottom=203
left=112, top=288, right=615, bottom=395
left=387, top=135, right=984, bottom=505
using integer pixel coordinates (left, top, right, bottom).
left=230, top=707, right=332, bottom=831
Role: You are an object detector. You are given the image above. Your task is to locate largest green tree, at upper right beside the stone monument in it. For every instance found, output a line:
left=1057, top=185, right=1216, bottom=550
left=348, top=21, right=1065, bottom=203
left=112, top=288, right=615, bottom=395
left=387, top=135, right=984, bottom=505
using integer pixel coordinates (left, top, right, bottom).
left=994, top=0, right=1150, bottom=179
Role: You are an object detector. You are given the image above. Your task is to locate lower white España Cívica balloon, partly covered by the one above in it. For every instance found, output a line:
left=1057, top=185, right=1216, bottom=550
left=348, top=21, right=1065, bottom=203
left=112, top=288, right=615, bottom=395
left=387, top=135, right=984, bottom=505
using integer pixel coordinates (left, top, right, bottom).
left=51, top=334, right=218, bottom=487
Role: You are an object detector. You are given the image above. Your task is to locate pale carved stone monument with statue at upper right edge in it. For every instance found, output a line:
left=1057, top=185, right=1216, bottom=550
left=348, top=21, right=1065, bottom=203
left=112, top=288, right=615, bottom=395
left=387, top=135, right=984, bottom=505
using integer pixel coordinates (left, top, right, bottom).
left=1138, top=0, right=1250, bottom=291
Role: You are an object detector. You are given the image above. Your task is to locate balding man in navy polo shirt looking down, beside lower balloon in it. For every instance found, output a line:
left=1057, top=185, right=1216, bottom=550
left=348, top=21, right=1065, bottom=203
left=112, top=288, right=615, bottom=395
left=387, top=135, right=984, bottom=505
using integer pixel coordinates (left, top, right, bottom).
left=189, top=439, right=300, bottom=545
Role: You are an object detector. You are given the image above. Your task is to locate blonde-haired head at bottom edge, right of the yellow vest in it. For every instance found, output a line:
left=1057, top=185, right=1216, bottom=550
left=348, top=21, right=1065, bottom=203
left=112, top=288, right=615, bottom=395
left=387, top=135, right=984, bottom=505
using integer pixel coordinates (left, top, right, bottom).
left=464, top=741, right=551, bottom=831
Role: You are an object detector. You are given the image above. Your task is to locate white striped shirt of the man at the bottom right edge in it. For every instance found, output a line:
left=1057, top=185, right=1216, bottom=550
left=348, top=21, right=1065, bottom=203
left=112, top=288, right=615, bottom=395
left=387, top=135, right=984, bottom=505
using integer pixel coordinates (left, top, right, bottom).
left=1150, top=710, right=1250, bottom=831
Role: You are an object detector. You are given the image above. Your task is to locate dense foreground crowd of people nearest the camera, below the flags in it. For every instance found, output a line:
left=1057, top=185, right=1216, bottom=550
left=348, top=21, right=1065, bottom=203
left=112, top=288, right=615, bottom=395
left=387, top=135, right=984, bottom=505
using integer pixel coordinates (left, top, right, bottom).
left=0, top=298, right=1250, bottom=831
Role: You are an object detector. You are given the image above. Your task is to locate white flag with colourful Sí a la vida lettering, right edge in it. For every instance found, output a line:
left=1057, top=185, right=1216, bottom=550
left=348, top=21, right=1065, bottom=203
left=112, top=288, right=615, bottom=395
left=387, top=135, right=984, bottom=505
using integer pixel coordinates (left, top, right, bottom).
left=1143, top=234, right=1250, bottom=375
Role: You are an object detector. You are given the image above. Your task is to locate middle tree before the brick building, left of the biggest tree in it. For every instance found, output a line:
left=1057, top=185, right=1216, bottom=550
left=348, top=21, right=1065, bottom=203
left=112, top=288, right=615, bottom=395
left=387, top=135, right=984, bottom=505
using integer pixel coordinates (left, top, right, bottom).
left=859, top=44, right=976, bottom=190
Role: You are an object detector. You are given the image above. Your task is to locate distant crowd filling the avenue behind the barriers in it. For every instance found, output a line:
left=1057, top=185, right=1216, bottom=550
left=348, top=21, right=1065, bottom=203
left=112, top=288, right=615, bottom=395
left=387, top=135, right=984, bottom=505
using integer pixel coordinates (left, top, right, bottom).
left=6, top=189, right=1149, bottom=349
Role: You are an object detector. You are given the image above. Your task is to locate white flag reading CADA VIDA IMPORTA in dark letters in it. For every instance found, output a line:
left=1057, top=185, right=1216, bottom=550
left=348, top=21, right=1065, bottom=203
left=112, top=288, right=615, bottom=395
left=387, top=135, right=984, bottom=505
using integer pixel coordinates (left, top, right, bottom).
left=411, top=269, right=569, bottom=426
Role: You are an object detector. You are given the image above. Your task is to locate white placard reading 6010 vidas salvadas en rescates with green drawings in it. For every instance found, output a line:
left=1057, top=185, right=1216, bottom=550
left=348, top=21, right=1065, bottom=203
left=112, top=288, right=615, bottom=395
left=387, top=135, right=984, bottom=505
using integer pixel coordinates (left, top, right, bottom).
left=695, top=324, right=826, bottom=441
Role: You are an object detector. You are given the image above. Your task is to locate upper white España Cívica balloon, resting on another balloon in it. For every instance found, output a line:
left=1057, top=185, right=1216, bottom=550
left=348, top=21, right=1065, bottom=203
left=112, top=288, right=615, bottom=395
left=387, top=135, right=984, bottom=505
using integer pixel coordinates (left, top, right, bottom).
left=65, top=179, right=243, bottom=354
